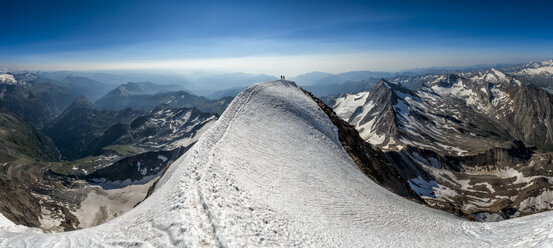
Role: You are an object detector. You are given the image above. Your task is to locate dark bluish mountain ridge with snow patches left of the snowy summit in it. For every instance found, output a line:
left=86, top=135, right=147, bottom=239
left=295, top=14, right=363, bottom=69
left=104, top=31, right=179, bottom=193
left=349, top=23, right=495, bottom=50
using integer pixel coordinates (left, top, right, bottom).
left=44, top=94, right=216, bottom=160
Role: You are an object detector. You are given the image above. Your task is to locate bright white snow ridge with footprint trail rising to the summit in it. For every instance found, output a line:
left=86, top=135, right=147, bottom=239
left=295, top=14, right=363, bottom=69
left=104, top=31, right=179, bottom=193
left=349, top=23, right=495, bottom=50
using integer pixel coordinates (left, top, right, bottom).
left=0, top=81, right=553, bottom=247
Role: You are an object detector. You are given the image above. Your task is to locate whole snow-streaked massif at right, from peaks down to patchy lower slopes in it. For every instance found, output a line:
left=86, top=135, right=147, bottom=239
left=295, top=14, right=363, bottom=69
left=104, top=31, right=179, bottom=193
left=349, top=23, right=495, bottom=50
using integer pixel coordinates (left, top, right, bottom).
left=334, top=69, right=553, bottom=220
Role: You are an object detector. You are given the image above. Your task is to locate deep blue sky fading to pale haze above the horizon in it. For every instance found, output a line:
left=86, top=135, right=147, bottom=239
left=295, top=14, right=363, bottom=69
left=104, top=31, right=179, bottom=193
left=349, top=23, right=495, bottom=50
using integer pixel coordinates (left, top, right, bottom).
left=0, top=0, right=553, bottom=75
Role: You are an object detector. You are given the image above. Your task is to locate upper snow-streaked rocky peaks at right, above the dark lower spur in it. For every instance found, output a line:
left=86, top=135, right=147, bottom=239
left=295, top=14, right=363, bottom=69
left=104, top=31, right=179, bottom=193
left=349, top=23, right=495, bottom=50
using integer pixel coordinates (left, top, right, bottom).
left=334, top=70, right=553, bottom=154
